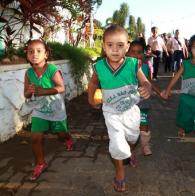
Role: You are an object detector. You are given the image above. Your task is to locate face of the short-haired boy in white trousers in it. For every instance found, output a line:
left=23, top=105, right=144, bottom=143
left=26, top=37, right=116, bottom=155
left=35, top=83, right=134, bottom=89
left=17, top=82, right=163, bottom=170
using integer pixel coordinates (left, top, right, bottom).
left=103, top=33, right=129, bottom=63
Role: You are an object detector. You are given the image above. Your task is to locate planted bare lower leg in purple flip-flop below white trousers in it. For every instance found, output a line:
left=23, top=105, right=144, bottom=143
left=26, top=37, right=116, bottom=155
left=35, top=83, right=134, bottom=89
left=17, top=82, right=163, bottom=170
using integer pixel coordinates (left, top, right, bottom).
left=114, top=159, right=126, bottom=192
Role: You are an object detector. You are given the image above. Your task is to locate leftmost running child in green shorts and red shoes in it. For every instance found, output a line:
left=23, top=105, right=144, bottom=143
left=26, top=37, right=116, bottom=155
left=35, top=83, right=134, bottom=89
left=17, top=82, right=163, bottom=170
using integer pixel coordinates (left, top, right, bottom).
left=24, top=39, right=73, bottom=180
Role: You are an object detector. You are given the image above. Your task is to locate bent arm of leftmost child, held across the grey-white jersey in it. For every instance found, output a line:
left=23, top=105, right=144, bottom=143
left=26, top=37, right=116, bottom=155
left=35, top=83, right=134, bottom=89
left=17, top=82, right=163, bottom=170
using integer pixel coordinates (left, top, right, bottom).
left=35, top=71, right=65, bottom=96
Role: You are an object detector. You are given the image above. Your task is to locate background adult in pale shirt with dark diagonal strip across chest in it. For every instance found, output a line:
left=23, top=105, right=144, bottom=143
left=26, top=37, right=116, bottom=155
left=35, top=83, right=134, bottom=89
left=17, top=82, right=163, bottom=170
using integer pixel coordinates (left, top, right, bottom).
left=170, top=29, right=188, bottom=75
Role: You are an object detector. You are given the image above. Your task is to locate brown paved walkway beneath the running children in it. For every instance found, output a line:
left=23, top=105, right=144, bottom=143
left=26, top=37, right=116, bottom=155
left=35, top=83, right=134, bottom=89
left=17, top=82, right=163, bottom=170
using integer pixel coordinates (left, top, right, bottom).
left=0, top=68, right=195, bottom=196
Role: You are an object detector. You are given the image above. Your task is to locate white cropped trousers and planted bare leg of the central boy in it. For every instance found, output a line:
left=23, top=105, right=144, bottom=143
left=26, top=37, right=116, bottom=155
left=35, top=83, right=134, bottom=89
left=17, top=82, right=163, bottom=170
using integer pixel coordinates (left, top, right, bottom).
left=103, top=106, right=140, bottom=191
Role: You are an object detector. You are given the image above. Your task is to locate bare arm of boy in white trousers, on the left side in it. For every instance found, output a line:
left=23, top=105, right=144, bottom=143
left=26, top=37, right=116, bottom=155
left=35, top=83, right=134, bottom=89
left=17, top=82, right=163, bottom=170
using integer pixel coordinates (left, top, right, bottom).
left=88, top=73, right=98, bottom=106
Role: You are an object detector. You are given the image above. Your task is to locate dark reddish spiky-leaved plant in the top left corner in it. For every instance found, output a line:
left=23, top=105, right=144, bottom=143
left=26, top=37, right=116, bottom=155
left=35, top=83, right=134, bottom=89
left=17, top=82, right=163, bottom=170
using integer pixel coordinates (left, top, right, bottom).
left=0, top=0, right=60, bottom=38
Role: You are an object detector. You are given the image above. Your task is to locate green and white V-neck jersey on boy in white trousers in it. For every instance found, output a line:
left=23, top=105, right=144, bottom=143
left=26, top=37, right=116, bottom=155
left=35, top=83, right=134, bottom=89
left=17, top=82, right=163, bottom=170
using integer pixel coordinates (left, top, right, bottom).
left=94, top=57, right=140, bottom=113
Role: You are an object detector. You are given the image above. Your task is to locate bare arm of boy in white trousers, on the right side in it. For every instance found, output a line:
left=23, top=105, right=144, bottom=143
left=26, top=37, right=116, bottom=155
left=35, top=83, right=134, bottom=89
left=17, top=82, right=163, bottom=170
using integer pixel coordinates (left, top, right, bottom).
left=137, top=68, right=152, bottom=99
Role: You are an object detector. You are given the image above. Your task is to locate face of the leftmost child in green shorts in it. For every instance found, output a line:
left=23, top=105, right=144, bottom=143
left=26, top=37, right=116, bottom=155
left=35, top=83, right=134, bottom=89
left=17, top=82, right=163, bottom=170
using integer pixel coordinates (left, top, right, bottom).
left=27, top=42, right=48, bottom=68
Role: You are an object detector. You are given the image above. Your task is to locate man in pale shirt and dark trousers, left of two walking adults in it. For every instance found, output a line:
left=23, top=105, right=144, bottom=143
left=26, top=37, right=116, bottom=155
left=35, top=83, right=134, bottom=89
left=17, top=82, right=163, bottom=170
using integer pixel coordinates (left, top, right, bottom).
left=148, top=27, right=169, bottom=80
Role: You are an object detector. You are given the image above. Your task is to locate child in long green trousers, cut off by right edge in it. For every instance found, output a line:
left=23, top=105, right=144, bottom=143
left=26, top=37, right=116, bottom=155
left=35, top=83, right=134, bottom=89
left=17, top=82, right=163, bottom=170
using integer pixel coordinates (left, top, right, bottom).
left=161, top=35, right=195, bottom=137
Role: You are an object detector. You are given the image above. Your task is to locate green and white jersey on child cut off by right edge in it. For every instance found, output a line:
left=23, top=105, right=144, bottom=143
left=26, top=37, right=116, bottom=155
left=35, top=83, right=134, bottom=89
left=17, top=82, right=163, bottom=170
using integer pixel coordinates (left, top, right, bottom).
left=181, top=59, right=195, bottom=96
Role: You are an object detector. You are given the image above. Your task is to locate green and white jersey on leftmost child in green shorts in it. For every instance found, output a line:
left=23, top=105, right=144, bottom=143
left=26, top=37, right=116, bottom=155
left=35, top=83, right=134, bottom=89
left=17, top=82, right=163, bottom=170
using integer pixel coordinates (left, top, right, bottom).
left=27, top=64, right=66, bottom=121
